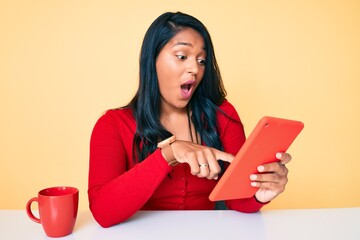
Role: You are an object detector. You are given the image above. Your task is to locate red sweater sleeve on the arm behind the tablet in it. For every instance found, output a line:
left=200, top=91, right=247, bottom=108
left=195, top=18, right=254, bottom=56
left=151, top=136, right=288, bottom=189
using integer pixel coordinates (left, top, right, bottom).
left=218, top=101, right=265, bottom=213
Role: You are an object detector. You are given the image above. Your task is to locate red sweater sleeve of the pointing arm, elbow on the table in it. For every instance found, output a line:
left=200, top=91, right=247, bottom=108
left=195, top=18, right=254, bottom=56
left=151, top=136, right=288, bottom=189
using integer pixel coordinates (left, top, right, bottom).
left=88, top=110, right=171, bottom=227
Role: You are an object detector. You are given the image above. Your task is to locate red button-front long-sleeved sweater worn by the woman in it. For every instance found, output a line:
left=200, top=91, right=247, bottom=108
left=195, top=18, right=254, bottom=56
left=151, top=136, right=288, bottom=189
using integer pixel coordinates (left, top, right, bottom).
left=88, top=101, right=263, bottom=227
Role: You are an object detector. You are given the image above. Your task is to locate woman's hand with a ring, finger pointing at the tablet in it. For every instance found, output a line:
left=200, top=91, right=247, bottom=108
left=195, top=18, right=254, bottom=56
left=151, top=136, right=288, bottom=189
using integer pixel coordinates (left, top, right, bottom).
left=170, top=140, right=234, bottom=180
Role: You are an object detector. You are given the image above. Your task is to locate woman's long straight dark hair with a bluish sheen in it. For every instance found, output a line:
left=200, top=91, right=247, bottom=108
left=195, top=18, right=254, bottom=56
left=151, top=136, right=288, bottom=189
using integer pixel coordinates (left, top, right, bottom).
left=128, top=12, right=226, bottom=162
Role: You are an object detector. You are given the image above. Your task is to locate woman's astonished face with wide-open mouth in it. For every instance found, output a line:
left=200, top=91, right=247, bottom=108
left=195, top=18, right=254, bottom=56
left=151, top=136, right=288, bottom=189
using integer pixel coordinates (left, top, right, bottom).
left=156, top=28, right=206, bottom=111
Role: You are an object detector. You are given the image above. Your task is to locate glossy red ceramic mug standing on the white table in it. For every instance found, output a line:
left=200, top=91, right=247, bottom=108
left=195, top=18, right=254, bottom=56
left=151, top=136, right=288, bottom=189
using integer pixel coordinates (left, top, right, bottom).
left=26, top=187, right=79, bottom=237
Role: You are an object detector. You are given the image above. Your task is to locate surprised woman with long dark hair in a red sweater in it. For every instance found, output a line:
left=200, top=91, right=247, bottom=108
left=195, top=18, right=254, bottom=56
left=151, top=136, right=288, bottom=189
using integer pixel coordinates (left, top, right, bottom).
left=88, top=12, right=291, bottom=227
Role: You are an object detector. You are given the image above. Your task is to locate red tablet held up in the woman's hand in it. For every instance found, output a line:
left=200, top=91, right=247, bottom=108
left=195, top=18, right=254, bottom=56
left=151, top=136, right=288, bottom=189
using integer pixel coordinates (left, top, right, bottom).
left=209, top=116, right=304, bottom=201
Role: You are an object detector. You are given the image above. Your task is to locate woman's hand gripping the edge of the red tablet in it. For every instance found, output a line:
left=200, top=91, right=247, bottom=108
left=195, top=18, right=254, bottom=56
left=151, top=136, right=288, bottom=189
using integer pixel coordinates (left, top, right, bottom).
left=250, top=153, right=291, bottom=203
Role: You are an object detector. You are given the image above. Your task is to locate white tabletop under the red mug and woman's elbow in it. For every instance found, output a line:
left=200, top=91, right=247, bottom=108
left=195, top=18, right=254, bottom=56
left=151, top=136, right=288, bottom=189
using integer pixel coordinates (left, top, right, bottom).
left=0, top=207, right=360, bottom=240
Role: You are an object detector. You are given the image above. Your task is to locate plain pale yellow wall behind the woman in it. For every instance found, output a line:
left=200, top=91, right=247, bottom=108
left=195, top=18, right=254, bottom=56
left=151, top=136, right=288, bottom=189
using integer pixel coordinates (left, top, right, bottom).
left=0, top=0, right=360, bottom=209
